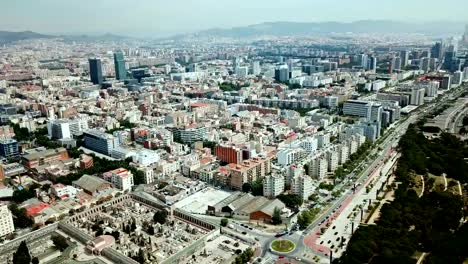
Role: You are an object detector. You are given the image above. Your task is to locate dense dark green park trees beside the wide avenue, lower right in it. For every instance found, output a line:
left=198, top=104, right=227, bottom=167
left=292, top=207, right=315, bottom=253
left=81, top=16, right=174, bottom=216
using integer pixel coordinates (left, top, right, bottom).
left=335, top=126, right=468, bottom=264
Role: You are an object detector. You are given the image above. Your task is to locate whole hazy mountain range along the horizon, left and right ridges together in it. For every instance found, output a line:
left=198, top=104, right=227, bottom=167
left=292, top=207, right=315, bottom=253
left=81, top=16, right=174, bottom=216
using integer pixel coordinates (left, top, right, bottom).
left=0, top=20, right=464, bottom=43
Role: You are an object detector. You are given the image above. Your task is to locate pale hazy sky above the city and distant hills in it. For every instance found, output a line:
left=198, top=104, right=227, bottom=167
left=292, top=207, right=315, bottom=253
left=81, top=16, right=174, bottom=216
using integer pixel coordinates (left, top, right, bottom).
left=0, top=0, right=468, bottom=36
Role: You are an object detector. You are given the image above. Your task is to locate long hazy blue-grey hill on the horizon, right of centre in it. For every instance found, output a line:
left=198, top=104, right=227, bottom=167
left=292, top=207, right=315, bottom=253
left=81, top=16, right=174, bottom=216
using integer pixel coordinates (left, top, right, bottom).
left=177, top=20, right=464, bottom=38
